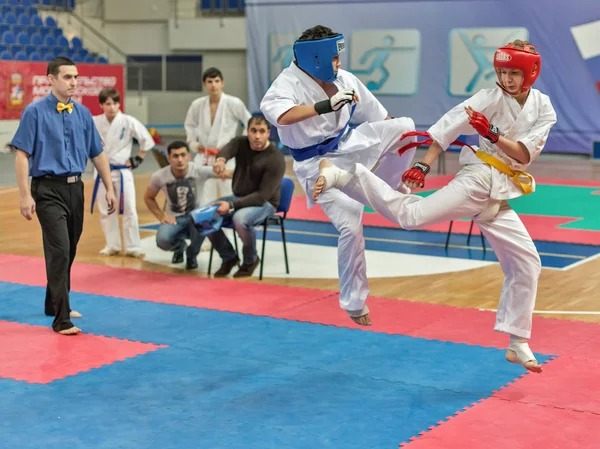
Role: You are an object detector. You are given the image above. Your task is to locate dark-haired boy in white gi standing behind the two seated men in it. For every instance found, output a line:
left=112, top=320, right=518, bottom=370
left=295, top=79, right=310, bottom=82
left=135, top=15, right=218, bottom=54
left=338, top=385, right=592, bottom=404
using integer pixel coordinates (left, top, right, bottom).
left=184, top=67, right=252, bottom=204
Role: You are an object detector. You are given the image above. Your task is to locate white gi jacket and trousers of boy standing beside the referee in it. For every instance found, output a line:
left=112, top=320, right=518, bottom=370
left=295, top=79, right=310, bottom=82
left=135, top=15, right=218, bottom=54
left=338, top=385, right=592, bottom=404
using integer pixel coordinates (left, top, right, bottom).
left=94, top=111, right=154, bottom=253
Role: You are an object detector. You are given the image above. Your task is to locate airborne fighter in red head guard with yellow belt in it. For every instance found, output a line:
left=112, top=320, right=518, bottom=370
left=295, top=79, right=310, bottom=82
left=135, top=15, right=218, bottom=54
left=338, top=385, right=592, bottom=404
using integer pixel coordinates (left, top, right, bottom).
left=314, top=41, right=556, bottom=373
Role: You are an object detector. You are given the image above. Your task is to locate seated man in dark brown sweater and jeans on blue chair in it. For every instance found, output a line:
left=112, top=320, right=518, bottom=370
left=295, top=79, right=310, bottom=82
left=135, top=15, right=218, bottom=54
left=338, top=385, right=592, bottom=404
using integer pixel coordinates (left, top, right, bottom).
left=208, top=116, right=285, bottom=278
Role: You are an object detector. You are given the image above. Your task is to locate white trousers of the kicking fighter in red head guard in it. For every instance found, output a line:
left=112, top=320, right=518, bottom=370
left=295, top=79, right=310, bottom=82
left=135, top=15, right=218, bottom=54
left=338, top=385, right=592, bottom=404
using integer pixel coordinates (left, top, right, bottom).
left=333, top=164, right=541, bottom=338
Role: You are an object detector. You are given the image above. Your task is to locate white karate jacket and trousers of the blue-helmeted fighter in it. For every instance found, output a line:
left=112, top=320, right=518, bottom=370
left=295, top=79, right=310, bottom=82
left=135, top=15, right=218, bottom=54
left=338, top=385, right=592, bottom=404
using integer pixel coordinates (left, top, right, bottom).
left=260, top=63, right=415, bottom=316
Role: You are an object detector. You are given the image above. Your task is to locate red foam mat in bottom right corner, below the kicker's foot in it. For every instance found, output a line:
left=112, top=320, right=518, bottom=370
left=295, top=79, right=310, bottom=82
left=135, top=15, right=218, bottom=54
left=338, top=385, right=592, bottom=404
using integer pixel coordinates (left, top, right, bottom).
left=400, top=398, right=600, bottom=449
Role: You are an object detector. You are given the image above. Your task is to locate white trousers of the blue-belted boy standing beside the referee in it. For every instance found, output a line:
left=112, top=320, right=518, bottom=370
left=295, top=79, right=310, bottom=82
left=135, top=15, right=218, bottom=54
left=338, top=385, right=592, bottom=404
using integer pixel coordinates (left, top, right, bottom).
left=96, top=169, right=141, bottom=252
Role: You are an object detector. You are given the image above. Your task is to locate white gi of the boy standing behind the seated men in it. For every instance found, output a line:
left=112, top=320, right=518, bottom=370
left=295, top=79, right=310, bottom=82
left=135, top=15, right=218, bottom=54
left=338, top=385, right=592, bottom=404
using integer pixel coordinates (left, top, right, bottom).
left=184, top=94, right=252, bottom=205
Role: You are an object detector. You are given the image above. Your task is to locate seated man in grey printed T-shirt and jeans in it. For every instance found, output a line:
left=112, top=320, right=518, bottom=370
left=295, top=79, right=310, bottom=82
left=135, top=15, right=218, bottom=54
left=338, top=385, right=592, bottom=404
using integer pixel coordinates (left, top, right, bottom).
left=144, top=141, right=232, bottom=270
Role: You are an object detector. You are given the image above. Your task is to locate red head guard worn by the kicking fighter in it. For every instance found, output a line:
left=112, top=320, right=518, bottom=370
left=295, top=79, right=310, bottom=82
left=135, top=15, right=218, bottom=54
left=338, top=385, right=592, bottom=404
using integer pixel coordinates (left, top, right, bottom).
left=494, top=43, right=542, bottom=93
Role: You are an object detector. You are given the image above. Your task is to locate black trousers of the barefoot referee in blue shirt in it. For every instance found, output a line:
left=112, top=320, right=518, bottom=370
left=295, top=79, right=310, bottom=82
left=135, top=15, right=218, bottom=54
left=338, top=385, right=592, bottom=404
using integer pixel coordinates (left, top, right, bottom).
left=31, top=177, right=84, bottom=332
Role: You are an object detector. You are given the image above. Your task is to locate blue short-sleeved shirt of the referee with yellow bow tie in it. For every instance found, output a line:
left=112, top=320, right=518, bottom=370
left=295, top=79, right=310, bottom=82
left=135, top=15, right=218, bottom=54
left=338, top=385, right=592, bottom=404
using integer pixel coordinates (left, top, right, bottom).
left=10, top=93, right=102, bottom=177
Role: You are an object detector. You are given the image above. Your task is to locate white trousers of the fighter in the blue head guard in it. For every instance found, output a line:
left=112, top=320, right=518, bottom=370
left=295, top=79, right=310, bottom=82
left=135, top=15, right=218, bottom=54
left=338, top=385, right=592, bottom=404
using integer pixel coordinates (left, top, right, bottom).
left=306, top=117, right=416, bottom=316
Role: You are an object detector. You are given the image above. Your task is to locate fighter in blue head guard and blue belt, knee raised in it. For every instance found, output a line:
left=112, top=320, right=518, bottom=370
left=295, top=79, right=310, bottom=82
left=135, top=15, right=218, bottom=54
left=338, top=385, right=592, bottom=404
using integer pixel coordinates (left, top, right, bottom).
left=260, top=25, right=415, bottom=326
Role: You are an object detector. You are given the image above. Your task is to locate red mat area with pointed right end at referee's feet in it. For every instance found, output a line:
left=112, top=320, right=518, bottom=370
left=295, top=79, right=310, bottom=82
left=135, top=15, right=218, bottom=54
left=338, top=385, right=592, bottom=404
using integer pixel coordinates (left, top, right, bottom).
left=0, top=321, right=166, bottom=384
